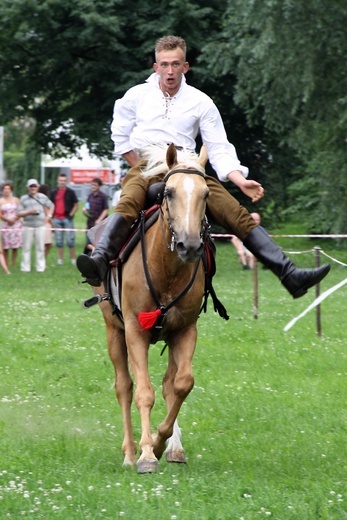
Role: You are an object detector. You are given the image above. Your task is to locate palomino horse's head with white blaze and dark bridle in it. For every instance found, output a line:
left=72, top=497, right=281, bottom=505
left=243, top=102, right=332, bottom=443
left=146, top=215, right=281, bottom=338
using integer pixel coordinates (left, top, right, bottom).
left=163, top=145, right=209, bottom=262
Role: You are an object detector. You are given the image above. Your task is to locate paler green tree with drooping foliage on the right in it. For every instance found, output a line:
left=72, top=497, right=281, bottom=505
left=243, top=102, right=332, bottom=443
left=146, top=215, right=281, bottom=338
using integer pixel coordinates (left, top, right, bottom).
left=201, top=0, right=347, bottom=232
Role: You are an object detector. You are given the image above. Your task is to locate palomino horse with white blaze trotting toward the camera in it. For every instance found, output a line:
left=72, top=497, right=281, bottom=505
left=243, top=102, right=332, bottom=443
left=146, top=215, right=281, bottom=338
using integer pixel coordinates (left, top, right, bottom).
left=94, top=145, right=209, bottom=473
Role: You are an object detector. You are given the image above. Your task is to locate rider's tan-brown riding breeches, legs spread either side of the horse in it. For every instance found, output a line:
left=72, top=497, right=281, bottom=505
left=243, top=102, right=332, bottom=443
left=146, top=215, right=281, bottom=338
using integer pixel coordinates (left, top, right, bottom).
left=115, top=168, right=257, bottom=241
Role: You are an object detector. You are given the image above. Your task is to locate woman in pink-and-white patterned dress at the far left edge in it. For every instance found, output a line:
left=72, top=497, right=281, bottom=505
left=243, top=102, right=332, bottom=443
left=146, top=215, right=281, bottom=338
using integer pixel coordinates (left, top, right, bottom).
left=0, top=182, right=22, bottom=267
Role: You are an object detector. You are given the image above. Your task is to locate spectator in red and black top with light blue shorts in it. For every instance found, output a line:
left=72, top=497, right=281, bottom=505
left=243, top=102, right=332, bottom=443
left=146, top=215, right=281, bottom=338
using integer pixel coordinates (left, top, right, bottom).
left=51, top=173, right=78, bottom=265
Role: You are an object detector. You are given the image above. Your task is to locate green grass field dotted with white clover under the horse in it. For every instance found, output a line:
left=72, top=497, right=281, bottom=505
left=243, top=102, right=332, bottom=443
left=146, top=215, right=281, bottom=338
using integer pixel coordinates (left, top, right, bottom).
left=0, top=218, right=347, bottom=520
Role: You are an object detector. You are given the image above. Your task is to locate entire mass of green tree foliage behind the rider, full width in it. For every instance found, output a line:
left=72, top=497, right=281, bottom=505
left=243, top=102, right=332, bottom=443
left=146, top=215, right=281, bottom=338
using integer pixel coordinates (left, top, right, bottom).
left=0, top=0, right=347, bottom=232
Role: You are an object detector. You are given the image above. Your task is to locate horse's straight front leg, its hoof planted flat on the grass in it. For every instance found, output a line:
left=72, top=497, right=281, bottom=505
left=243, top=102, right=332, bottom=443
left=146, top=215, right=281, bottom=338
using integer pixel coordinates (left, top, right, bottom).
left=126, top=326, right=158, bottom=473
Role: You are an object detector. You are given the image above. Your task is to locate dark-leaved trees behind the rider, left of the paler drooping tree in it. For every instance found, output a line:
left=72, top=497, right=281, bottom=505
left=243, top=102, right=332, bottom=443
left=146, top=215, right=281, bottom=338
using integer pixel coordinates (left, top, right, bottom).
left=0, top=0, right=306, bottom=228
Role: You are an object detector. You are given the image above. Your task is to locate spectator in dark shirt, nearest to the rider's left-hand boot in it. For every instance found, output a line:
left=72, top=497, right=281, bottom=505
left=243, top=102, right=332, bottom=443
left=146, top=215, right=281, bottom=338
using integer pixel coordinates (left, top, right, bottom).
left=82, top=177, right=108, bottom=254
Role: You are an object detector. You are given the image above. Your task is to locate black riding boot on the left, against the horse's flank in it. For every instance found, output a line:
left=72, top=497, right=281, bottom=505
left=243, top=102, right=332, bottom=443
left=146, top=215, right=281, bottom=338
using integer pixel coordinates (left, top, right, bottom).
left=76, top=213, right=130, bottom=287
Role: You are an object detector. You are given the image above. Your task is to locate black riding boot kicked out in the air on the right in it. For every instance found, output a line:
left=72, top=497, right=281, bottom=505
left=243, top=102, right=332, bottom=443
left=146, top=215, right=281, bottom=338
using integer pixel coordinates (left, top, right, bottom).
left=243, top=226, right=330, bottom=298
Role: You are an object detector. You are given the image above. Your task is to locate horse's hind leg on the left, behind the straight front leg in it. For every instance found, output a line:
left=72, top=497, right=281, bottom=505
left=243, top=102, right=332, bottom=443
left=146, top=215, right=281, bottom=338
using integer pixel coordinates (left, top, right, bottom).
left=107, top=325, right=136, bottom=467
